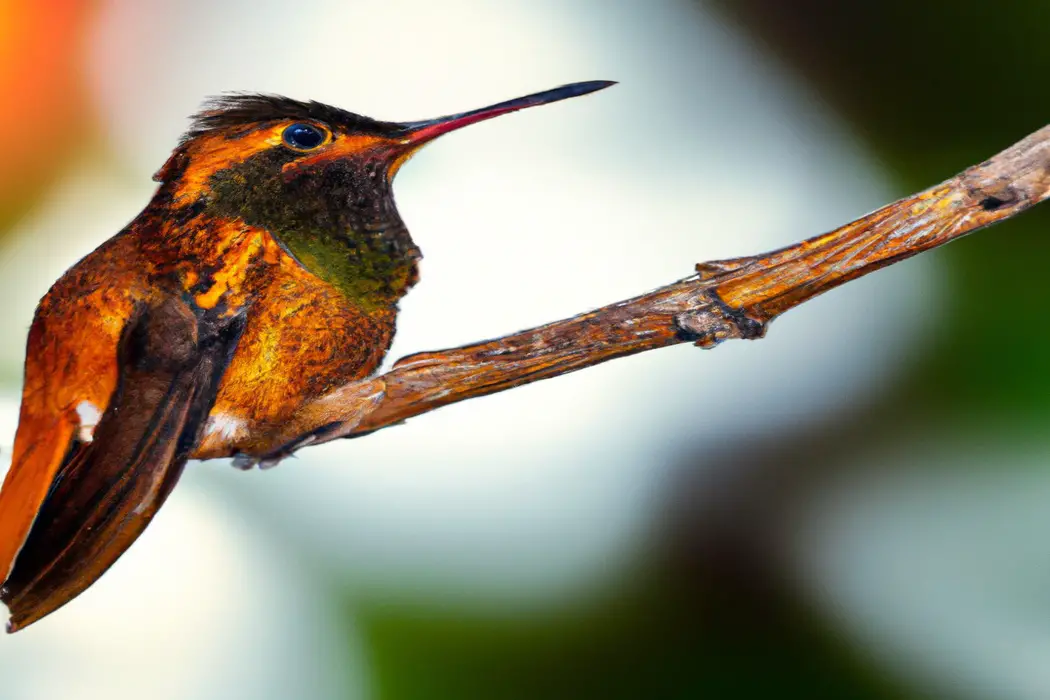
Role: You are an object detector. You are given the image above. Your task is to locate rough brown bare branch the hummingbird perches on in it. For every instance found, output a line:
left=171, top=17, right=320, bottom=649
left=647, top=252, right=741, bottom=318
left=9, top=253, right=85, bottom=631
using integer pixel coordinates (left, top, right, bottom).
left=197, top=127, right=1050, bottom=466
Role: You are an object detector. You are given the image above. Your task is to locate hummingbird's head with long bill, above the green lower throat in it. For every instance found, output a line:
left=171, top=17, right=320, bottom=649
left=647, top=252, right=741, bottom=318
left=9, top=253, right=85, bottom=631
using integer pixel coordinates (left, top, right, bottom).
left=154, top=81, right=612, bottom=233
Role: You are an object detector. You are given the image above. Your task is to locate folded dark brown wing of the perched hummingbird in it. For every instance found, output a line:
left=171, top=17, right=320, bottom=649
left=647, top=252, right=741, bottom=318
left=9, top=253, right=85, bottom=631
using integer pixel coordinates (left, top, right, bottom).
left=0, top=298, right=244, bottom=632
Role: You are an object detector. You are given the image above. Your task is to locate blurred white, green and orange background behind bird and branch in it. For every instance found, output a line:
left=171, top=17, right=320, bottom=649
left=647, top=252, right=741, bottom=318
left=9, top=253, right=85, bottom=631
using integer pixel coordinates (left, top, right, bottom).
left=0, top=0, right=1050, bottom=700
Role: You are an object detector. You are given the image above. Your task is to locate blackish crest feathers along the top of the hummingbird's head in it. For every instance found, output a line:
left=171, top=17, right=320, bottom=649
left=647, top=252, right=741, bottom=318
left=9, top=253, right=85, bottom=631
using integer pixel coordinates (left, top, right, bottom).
left=183, top=92, right=402, bottom=141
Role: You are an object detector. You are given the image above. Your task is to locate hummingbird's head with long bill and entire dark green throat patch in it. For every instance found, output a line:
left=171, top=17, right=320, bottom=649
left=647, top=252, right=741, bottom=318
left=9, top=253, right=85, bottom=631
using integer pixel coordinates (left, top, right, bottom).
left=154, top=81, right=612, bottom=304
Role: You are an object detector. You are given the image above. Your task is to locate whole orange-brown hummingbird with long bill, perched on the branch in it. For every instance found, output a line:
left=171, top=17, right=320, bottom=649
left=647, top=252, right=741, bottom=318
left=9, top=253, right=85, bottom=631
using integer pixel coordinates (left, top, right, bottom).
left=0, top=81, right=613, bottom=632
